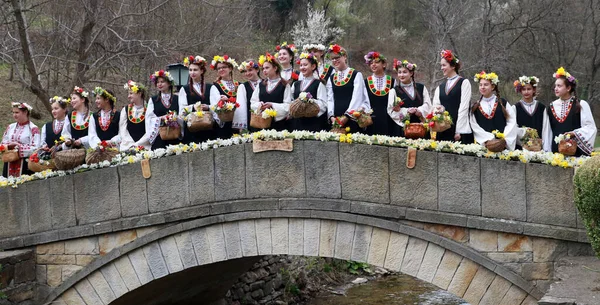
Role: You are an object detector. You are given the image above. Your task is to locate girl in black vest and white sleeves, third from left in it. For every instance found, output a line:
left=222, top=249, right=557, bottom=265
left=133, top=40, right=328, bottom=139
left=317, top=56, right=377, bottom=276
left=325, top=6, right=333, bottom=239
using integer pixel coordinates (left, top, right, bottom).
left=61, top=87, right=100, bottom=149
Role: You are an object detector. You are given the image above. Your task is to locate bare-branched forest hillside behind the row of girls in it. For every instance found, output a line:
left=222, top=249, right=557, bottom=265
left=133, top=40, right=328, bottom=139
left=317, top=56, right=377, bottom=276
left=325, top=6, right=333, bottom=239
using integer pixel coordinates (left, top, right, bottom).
left=0, top=0, right=600, bottom=138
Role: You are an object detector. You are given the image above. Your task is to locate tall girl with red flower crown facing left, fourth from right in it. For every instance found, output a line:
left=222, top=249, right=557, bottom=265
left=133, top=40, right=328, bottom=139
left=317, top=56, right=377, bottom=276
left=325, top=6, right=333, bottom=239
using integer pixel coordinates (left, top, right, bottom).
left=433, top=50, right=473, bottom=144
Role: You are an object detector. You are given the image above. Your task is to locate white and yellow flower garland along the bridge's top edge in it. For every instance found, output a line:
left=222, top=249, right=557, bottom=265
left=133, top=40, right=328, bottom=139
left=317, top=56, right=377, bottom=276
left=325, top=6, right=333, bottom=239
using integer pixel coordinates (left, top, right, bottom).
left=0, top=130, right=596, bottom=187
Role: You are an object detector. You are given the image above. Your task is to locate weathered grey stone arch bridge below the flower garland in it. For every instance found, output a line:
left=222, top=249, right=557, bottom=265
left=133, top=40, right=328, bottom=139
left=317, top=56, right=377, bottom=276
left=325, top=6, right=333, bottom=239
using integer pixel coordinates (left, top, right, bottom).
left=0, top=141, right=591, bottom=305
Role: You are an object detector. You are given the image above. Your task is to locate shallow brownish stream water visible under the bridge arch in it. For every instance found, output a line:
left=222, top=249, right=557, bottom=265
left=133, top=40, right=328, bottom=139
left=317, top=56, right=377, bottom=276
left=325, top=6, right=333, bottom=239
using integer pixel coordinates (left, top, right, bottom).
left=308, top=274, right=469, bottom=305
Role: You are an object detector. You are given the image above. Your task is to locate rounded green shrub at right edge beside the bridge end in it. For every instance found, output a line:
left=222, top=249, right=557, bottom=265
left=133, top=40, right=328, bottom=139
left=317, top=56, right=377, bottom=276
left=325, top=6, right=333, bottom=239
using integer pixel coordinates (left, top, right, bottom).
left=573, top=156, right=600, bottom=258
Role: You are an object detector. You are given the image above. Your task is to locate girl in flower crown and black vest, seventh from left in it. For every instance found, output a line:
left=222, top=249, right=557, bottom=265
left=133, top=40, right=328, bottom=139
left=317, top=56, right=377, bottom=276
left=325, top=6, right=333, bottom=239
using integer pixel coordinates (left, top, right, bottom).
left=178, top=56, right=217, bottom=143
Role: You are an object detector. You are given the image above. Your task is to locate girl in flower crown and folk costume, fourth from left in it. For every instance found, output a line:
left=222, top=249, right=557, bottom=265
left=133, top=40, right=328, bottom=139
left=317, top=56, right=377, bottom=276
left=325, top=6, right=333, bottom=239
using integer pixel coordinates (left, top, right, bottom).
left=94, top=87, right=121, bottom=147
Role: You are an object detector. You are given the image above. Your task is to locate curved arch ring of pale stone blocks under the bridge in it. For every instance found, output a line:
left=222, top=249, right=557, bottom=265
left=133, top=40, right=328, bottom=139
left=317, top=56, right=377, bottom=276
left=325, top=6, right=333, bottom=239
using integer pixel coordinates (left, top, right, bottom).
left=44, top=211, right=542, bottom=305
